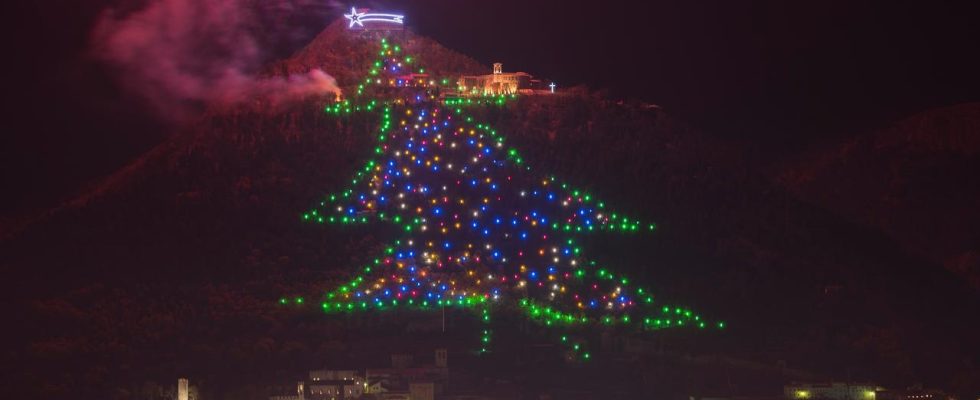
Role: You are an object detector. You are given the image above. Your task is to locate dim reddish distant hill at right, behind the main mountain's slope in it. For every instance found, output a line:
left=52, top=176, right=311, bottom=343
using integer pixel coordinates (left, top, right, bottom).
left=779, top=103, right=980, bottom=288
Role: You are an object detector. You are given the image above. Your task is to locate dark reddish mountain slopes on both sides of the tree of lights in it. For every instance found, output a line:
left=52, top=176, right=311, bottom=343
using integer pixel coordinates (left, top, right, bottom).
left=0, top=19, right=980, bottom=398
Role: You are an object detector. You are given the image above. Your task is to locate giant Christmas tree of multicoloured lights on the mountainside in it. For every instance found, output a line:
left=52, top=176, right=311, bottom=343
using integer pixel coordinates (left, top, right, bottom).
left=288, top=32, right=725, bottom=360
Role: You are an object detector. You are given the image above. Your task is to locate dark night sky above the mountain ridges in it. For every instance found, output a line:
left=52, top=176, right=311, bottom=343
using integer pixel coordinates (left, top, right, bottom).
left=0, top=0, right=980, bottom=216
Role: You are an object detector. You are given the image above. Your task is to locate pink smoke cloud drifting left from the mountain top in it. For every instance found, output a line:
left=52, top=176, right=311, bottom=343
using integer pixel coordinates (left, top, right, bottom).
left=93, top=0, right=340, bottom=121
